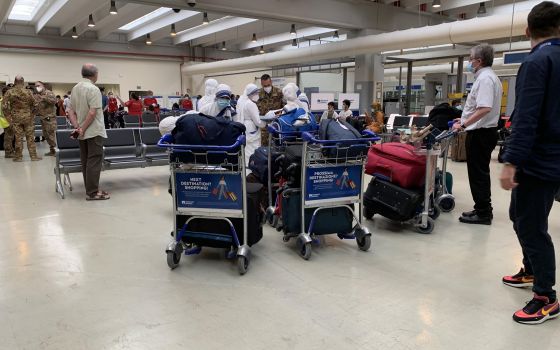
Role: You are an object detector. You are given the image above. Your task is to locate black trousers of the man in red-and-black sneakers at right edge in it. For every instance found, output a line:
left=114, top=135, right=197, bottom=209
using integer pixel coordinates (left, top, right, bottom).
left=509, top=171, right=560, bottom=299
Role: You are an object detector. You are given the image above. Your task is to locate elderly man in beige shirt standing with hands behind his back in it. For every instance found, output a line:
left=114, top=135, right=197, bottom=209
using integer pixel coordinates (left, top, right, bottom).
left=68, top=63, right=110, bottom=200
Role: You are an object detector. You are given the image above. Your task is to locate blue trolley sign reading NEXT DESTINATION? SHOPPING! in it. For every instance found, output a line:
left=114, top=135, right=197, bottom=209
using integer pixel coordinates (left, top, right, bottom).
left=175, top=173, right=243, bottom=210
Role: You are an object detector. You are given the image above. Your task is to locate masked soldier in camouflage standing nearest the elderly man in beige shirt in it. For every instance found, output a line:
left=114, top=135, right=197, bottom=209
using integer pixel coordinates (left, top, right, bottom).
left=33, top=81, right=56, bottom=156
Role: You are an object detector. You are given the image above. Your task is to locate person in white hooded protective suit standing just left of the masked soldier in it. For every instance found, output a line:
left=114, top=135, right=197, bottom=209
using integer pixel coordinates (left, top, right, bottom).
left=234, top=84, right=266, bottom=166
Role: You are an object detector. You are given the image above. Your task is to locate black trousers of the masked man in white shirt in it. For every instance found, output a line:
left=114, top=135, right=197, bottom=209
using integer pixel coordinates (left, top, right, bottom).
left=466, top=128, right=498, bottom=215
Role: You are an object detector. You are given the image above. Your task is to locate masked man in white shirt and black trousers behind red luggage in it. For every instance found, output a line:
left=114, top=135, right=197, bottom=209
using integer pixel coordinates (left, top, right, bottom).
left=453, top=45, right=503, bottom=225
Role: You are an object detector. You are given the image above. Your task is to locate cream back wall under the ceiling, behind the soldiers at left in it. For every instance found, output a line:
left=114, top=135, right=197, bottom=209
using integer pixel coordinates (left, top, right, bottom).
left=0, top=52, right=181, bottom=98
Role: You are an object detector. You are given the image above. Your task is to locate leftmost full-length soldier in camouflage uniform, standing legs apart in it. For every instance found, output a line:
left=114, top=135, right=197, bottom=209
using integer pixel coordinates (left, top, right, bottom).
left=2, top=75, right=42, bottom=162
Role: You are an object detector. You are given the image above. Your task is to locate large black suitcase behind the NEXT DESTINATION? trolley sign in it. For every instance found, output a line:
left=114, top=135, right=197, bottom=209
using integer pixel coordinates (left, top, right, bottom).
left=177, top=183, right=263, bottom=248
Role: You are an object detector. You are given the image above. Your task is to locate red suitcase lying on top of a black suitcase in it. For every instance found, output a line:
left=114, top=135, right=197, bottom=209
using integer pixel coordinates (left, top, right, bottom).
left=366, top=142, right=426, bottom=188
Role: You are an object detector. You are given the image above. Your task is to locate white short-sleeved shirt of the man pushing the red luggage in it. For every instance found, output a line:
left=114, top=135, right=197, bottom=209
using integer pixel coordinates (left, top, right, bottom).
left=461, top=67, right=503, bottom=131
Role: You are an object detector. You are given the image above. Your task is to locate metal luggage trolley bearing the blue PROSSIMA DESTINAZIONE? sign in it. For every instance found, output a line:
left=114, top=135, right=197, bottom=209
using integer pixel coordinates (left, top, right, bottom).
left=283, top=131, right=380, bottom=260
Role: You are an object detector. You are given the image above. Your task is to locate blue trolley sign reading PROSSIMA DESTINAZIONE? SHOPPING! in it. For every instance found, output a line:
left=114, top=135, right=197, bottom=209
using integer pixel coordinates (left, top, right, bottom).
left=305, top=165, right=362, bottom=201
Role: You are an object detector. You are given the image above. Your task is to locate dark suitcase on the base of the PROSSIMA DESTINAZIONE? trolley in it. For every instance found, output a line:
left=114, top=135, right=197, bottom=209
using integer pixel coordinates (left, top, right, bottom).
left=282, top=192, right=354, bottom=235
